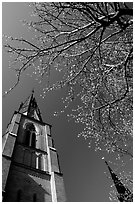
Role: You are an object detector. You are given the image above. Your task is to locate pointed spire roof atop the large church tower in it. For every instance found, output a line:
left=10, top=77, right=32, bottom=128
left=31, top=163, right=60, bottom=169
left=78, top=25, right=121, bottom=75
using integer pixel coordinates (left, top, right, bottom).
left=18, top=90, right=42, bottom=121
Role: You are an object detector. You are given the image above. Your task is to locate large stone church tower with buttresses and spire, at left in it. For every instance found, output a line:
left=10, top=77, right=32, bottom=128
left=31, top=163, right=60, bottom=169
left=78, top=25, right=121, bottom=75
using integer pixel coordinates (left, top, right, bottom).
left=2, top=91, right=66, bottom=202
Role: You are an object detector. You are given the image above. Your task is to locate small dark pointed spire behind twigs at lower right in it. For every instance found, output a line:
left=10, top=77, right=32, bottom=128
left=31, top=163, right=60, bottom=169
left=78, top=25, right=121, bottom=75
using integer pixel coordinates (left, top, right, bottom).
left=105, top=161, right=133, bottom=202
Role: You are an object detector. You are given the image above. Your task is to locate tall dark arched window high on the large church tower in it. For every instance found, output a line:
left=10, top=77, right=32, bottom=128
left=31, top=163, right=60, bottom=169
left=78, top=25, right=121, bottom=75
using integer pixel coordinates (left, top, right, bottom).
left=24, top=123, right=36, bottom=148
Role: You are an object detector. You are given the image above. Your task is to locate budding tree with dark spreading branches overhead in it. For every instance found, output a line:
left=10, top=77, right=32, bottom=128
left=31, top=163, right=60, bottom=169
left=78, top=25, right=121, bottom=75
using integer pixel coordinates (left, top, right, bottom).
left=4, top=2, right=133, bottom=157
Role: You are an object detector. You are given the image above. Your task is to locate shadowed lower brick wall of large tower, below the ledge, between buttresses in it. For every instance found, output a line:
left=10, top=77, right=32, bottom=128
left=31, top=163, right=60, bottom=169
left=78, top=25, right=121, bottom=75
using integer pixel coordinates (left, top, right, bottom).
left=4, top=164, right=52, bottom=202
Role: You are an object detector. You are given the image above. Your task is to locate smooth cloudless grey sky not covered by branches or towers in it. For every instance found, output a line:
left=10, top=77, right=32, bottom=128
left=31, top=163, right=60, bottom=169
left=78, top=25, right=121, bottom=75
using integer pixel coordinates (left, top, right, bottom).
left=2, top=2, right=125, bottom=202
